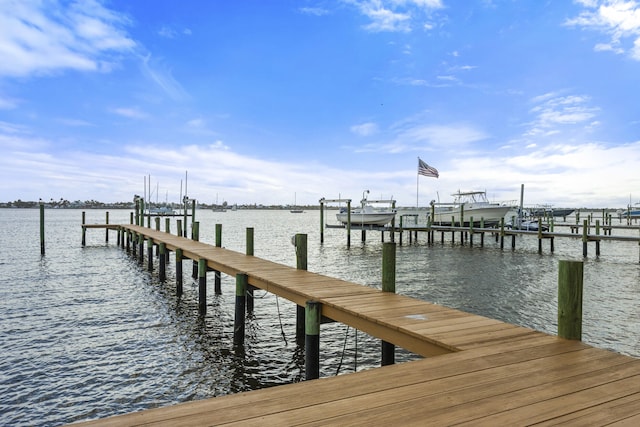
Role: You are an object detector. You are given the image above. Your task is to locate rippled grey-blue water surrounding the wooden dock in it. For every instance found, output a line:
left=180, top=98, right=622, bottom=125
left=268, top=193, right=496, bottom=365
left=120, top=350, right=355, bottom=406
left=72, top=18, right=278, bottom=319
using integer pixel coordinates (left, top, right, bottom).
left=0, top=209, right=640, bottom=425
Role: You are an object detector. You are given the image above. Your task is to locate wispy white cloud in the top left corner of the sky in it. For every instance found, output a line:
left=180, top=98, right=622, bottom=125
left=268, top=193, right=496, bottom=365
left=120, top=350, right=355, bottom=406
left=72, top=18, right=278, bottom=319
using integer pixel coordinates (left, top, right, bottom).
left=0, top=0, right=136, bottom=77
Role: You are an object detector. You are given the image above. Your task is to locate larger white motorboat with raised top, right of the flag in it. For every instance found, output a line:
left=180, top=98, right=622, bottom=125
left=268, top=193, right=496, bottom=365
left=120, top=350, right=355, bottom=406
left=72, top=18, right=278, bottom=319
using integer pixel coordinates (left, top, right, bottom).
left=429, top=191, right=513, bottom=227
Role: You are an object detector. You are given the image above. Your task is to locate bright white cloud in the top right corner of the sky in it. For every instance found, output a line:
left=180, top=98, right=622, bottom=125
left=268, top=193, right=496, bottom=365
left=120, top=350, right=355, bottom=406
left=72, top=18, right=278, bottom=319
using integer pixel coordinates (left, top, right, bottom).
left=565, top=0, right=640, bottom=61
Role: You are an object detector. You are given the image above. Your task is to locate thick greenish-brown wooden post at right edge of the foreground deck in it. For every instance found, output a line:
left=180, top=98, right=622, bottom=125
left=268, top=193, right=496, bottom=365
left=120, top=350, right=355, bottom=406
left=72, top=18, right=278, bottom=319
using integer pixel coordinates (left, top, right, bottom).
left=558, top=261, right=584, bottom=340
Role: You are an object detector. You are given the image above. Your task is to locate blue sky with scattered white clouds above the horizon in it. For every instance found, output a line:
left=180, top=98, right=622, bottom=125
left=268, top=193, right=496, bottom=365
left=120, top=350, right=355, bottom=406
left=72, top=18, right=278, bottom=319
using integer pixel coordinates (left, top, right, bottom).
left=0, top=0, right=640, bottom=207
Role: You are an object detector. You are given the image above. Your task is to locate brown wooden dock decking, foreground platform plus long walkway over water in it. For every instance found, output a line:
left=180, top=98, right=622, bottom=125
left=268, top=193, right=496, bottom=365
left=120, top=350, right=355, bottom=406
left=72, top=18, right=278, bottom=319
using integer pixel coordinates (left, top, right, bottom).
left=71, top=226, right=640, bottom=426
